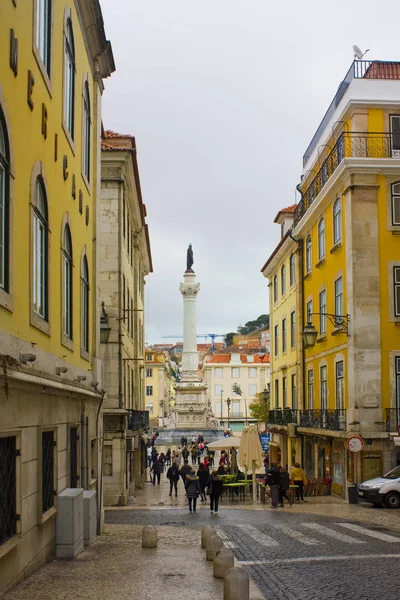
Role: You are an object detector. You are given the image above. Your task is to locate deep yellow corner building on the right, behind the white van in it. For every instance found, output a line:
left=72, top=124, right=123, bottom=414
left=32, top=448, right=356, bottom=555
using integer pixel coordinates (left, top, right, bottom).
left=292, top=61, right=400, bottom=496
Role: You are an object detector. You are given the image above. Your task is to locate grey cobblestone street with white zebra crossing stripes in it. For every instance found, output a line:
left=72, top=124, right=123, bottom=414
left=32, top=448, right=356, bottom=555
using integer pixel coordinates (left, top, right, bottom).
left=106, top=478, right=400, bottom=600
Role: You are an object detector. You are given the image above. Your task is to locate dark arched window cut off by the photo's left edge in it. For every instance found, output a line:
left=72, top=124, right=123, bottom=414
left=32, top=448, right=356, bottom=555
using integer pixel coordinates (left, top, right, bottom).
left=0, top=108, right=10, bottom=292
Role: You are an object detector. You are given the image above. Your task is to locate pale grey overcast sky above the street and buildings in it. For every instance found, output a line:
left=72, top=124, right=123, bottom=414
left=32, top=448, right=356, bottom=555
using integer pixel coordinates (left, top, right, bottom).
left=101, top=0, right=400, bottom=343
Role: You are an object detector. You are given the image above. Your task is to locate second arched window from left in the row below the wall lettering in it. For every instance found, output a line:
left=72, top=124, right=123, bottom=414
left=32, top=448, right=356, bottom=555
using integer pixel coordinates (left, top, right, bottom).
left=33, top=175, right=49, bottom=321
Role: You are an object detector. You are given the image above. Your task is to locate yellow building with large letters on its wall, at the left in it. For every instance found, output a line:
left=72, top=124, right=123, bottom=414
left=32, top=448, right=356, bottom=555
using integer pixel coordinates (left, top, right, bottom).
left=0, top=0, right=114, bottom=592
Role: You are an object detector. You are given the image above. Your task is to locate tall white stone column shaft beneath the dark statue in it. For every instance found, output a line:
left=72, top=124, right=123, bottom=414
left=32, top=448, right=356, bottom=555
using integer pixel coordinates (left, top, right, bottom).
left=179, top=271, right=200, bottom=381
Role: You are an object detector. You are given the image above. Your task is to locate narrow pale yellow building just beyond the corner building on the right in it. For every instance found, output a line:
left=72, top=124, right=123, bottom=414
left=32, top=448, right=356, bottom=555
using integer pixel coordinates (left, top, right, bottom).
left=261, top=205, right=303, bottom=467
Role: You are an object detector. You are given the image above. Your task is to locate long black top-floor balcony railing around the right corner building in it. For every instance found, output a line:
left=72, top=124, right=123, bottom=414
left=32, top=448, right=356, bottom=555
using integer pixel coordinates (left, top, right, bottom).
left=294, top=131, right=400, bottom=224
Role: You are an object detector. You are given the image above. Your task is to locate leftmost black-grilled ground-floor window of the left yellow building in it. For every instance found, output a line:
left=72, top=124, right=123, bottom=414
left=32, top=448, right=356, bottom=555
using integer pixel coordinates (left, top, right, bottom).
left=0, top=437, right=17, bottom=545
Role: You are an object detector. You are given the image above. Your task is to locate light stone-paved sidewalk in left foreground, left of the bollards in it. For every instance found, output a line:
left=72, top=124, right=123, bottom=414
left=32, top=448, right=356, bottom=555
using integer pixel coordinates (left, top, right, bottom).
left=5, top=525, right=223, bottom=600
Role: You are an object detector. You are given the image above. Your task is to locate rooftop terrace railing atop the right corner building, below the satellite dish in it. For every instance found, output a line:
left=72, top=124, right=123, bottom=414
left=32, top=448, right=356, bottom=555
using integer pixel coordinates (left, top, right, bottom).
left=303, top=60, right=400, bottom=167
